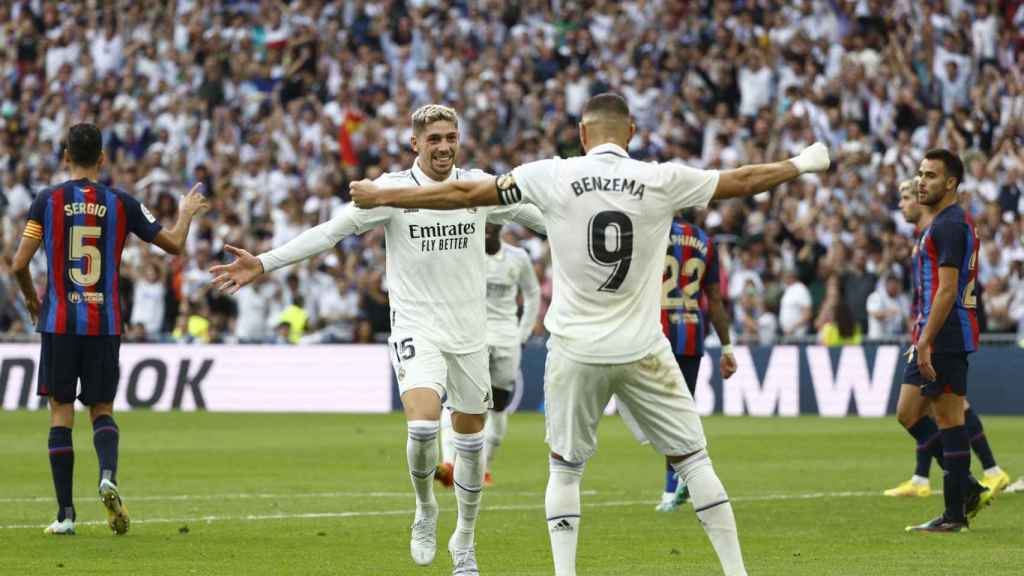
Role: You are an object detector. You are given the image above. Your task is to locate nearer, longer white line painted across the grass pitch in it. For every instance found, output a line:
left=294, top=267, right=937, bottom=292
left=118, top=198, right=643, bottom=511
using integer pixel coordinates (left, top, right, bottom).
left=0, top=491, right=881, bottom=530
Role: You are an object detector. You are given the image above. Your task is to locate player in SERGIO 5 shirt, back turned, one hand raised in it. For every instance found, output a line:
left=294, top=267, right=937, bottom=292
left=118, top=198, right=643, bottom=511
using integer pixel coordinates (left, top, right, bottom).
left=12, top=124, right=207, bottom=534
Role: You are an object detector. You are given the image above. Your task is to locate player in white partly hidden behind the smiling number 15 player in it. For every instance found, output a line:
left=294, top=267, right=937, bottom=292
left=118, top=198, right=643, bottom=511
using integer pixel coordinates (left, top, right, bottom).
left=435, top=224, right=541, bottom=487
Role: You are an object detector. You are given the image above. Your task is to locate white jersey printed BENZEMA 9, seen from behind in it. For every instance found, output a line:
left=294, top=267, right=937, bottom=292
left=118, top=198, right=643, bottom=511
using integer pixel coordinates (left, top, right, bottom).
left=498, top=143, right=719, bottom=364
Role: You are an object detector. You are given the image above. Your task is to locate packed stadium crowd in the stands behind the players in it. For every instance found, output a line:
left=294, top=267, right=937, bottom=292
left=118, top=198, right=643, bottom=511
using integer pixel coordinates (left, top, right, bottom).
left=0, top=0, right=1024, bottom=342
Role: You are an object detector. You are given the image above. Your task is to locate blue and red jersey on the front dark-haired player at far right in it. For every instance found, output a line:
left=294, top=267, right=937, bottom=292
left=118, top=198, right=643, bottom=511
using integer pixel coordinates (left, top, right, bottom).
left=913, top=204, right=979, bottom=353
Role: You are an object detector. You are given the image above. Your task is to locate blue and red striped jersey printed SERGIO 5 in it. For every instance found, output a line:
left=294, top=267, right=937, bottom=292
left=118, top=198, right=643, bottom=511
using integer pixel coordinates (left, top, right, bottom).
left=25, top=178, right=161, bottom=336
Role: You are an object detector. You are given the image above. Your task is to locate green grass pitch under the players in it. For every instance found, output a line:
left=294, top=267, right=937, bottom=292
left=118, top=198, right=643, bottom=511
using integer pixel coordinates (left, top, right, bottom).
left=0, top=412, right=1024, bottom=576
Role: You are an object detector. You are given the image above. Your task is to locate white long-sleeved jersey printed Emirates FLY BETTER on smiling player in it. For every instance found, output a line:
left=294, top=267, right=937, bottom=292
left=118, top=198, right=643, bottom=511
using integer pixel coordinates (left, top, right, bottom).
left=259, top=158, right=544, bottom=354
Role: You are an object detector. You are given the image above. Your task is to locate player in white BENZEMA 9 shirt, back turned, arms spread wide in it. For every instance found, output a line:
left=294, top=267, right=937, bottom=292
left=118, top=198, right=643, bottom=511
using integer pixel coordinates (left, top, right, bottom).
left=352, top=93, right=828, bottom=576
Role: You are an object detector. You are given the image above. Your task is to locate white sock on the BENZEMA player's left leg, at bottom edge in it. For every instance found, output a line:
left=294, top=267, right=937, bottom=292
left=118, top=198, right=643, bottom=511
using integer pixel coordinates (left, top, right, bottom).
left=544, top=458, right=584, bottom=576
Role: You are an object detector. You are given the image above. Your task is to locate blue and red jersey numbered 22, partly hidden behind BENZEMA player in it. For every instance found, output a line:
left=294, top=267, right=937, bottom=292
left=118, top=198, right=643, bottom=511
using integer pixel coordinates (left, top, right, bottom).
left=662, top=219, right=719, bottom=358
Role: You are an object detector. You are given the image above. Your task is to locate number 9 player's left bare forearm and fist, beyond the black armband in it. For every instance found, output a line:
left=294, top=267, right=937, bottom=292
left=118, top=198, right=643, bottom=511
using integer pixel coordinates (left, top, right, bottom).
left=350, top=177, right=501, bottom=210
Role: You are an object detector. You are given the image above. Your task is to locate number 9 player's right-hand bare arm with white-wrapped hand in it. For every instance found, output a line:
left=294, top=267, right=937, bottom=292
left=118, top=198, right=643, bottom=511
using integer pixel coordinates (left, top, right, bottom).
left=712, top=142, right=830, bottom=200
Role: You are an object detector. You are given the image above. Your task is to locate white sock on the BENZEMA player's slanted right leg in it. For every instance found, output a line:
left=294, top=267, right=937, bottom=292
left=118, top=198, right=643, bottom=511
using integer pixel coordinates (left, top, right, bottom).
left=672, top=450, right=746, bottom=576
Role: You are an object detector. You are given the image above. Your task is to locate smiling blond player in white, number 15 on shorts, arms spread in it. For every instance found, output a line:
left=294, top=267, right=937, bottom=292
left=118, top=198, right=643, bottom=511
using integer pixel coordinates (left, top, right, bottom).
left=210, top=105, right=544, bottom=574
